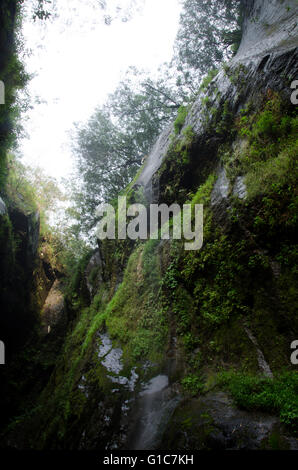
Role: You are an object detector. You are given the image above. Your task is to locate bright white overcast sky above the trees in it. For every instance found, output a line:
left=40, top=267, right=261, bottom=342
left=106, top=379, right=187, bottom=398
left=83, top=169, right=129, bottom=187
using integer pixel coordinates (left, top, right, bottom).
left=20, top=0, right=181, bottom=179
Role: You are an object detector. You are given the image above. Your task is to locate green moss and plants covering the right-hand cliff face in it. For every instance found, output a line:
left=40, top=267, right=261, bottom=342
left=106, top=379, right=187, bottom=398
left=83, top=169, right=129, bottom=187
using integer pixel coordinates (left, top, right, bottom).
left=4, top=56, right=298, bottom=447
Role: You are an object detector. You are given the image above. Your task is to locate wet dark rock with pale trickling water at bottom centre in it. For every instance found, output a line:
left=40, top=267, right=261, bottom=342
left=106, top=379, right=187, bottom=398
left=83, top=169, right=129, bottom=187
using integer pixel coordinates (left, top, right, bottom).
left=78, top=332, right=181, bottom=450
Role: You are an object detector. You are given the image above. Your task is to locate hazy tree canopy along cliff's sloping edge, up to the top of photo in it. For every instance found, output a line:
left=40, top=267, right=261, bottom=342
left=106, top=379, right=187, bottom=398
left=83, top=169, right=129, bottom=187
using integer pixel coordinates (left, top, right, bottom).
left=68, top=0, right=241, bottom=232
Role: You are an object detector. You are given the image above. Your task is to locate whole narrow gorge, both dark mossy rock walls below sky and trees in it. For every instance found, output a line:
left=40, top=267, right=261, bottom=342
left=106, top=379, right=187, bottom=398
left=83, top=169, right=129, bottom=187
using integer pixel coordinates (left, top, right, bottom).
left=0, top=0, right=298, bottom=452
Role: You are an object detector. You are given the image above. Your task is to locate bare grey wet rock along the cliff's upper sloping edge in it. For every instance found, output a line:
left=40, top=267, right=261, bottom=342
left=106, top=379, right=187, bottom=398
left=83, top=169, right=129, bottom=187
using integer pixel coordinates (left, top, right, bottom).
left=136, top=0, right=298, bottom=209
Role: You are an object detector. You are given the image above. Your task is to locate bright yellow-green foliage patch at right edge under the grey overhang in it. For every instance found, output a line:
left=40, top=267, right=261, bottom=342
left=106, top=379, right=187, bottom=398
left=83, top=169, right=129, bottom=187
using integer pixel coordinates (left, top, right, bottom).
left=226, top=90, right=298, bottom=198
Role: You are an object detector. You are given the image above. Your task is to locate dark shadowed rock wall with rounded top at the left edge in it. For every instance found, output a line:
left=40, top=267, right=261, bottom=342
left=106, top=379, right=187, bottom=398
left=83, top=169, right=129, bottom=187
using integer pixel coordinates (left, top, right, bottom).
left=0, top=211, right=43, bottom=348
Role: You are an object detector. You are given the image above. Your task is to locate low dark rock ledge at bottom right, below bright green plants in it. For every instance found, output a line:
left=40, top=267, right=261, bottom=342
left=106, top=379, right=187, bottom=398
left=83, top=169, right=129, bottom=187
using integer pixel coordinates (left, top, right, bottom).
left=160, top=392, right=298, bottom=451
